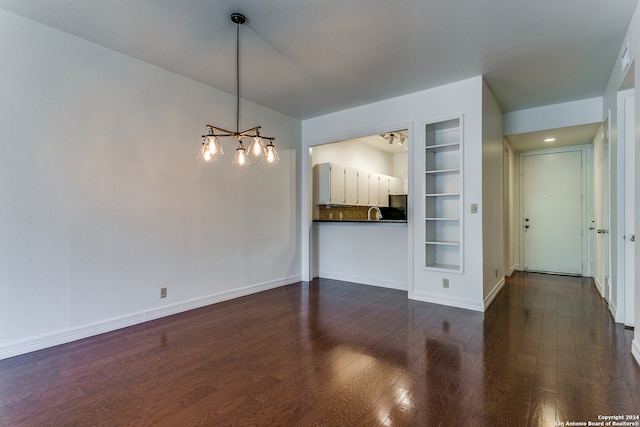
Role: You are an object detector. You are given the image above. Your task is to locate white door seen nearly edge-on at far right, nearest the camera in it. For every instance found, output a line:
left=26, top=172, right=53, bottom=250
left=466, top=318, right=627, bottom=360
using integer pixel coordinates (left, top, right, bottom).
left=624, top=95, right=636, bottom=326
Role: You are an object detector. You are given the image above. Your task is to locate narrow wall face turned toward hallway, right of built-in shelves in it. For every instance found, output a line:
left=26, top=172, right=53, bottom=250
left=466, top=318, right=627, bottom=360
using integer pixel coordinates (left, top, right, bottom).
left=482, top=79, right=505, bottom=307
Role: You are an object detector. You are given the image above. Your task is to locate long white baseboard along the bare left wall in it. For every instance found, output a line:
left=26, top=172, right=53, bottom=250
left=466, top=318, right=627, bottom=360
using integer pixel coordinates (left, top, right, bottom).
left=0, top=276, right=301, bottom=360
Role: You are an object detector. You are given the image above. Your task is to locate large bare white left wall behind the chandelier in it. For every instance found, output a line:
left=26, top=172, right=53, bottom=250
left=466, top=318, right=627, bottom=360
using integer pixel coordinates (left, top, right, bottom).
left=0, top=11, right=301, bottom=358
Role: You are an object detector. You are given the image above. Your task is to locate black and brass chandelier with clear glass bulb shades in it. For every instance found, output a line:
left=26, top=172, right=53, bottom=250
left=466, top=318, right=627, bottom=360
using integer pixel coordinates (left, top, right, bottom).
left=200, top=13, right=279, bottom=166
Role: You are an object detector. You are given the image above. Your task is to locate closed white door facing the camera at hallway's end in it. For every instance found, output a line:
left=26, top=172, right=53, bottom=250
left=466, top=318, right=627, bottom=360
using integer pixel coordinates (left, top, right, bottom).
left=522, top=150, right=584, bottom=275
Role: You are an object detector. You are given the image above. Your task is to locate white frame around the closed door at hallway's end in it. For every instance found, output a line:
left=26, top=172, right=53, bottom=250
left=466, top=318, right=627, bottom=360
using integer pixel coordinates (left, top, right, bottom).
left=518, top=145, right=590, bottom=276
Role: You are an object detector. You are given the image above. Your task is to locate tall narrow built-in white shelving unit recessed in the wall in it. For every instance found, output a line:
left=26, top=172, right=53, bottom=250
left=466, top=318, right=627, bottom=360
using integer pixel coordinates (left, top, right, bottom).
left=424, top=117, right=463, bottom=272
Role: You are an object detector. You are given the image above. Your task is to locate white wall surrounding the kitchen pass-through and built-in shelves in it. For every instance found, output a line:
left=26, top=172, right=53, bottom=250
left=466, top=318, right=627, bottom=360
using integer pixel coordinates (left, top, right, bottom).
left=301, top=76, right=484, bottom=310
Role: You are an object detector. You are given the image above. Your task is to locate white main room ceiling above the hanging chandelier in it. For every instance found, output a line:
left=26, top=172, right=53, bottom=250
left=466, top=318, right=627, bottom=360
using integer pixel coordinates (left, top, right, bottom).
left=0, top=0, right=638, bottom=119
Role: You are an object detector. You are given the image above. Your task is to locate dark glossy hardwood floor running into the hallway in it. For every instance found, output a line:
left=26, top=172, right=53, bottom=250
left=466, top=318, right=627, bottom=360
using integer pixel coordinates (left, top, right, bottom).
left=0, top=273, right=640, bottom=427
